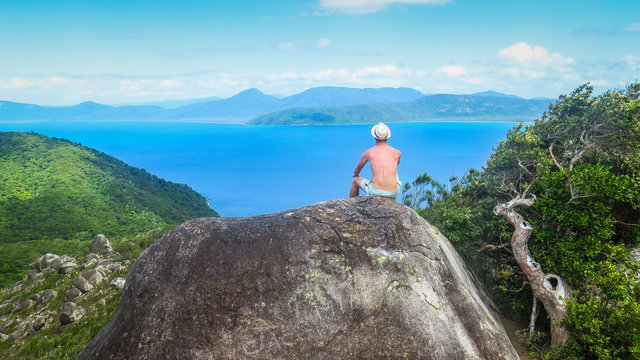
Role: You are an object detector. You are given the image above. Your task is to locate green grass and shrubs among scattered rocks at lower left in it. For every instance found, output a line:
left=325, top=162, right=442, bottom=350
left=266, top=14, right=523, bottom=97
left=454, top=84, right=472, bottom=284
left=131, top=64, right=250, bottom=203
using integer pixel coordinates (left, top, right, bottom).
left=0, top=227, right=170, bottom=360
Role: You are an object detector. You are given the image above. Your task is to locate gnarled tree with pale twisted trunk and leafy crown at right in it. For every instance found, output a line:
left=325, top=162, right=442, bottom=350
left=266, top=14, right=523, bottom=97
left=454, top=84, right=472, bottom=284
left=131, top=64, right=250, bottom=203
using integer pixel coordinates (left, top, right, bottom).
left=488, top=84, right=637, bottom=347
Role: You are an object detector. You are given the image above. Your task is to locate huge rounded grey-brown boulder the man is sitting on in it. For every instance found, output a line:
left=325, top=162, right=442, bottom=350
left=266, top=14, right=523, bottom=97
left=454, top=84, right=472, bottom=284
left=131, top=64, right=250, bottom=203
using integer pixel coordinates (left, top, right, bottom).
left=78, top=196, right=518, bottom=359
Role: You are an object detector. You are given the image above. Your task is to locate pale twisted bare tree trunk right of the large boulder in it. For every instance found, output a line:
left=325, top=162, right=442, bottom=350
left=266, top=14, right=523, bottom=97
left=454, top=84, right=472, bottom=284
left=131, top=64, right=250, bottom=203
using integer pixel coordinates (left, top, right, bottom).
left=493, top=196, right=571, bottom=347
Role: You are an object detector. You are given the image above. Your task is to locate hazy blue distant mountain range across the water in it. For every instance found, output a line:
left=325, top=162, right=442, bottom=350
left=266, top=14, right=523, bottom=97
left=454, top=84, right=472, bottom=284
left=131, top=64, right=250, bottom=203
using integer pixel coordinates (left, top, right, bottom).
left=0, top=87, right=550, bottom=125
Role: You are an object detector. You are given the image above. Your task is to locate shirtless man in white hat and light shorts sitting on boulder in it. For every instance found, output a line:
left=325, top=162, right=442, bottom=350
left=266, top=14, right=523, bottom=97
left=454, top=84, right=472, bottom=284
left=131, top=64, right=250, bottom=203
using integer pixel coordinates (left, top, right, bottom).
left=349, top=123, right=402, bottom=199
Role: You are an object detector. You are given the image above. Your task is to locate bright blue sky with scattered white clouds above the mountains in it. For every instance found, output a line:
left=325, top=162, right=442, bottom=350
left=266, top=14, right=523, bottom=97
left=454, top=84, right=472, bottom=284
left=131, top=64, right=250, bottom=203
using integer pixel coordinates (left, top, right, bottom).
left=0, top=0, right=640, bottom=105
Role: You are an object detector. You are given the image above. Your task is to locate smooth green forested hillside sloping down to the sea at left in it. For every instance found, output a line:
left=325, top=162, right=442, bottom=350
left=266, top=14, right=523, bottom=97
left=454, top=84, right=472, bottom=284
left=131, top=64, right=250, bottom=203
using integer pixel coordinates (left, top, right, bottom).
left=0, top=132, right=217, bottom=287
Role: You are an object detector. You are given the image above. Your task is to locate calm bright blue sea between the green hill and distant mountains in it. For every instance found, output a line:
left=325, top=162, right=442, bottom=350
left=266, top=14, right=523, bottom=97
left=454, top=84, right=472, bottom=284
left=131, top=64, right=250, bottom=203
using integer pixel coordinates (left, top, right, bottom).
left=0, top=122, right=515, bottom=216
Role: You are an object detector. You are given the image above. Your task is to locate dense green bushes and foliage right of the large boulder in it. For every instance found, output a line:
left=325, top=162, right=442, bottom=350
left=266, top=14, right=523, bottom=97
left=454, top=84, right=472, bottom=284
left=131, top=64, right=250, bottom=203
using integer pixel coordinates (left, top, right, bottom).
left=404, top=83, right=640, bottom=359
